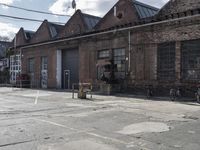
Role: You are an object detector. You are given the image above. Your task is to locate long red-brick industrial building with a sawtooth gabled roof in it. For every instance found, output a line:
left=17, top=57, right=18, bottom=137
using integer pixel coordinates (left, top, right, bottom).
left=11, top=0, right=200, bottom=95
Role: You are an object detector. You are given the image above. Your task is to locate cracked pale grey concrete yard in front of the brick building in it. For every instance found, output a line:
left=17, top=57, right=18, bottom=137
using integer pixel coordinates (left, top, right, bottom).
left=0, top=88, right=200, bottom=150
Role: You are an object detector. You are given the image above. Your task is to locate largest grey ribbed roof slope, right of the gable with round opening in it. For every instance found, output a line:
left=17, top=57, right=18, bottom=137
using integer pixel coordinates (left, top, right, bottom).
left=132, top=0, right=159, bottom=19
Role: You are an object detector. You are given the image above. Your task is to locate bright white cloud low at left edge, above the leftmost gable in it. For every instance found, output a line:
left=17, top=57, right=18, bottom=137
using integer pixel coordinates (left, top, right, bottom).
left=0, top=22, right=19, bottom=40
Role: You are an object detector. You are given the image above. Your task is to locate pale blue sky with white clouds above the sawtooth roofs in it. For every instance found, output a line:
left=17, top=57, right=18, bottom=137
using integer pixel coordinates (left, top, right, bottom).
left=0, top=0, right=168, bottom=39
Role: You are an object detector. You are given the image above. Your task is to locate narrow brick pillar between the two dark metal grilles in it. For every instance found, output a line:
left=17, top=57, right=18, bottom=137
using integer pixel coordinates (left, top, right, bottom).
left=175, top=41, right=181, bottom=83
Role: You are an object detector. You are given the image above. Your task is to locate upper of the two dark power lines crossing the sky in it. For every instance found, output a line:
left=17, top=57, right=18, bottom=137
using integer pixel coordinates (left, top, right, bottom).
left=0, top=3, right=71, bottom=17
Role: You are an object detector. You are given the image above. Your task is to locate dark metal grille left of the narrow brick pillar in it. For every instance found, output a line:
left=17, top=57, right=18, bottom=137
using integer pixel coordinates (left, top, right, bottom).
left=157, top=42, right=176, bottom=81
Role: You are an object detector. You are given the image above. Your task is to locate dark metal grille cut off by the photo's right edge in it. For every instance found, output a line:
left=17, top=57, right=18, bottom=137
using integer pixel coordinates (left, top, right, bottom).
left=181, top=40, right=200, bottom=81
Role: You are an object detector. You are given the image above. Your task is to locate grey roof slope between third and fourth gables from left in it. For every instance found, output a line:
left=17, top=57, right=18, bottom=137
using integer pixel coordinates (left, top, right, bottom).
left=82, top=13, right=101, bottom=30
